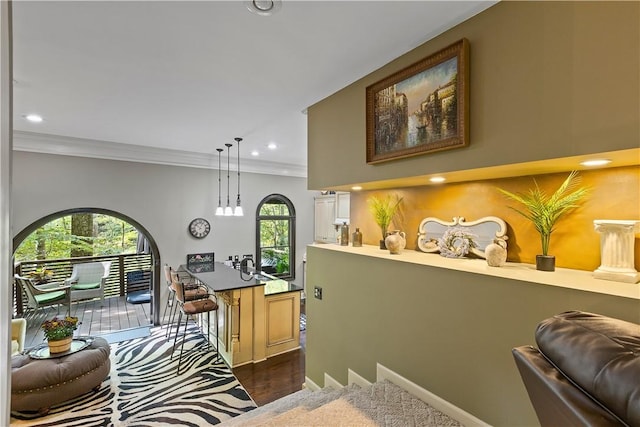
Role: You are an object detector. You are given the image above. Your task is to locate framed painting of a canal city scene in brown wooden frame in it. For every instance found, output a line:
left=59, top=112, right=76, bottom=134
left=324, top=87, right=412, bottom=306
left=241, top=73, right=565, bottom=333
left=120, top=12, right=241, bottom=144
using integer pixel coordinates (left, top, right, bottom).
left=367, top=39, right=469, bottom=164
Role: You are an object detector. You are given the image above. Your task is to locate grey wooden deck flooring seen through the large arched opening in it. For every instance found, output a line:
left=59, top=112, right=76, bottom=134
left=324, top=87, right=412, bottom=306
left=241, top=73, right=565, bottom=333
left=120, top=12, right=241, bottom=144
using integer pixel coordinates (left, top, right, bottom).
left=25, top=297, right=151, bottom=348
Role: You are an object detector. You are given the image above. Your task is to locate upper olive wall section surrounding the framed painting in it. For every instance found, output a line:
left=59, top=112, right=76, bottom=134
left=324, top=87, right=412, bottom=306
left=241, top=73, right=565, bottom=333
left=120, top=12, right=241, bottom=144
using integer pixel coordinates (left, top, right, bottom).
left=308, top=1, right=640, bottom=190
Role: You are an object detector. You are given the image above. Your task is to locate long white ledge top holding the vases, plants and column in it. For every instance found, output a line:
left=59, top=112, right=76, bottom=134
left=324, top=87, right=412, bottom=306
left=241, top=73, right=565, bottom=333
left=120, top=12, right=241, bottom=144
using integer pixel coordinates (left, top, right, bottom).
left=310, top=243, right=640, bottom=300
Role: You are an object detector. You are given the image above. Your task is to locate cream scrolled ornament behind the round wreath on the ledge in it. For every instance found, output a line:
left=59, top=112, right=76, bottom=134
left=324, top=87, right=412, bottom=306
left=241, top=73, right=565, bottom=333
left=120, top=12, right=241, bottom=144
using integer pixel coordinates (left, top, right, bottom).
left=418, top=216, right=507, bottom=258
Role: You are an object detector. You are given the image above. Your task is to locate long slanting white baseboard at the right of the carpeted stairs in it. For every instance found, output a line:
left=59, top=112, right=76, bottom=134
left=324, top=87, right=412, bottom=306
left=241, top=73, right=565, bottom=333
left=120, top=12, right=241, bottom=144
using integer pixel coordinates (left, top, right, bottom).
left=376, top=363, right=490, bottom=427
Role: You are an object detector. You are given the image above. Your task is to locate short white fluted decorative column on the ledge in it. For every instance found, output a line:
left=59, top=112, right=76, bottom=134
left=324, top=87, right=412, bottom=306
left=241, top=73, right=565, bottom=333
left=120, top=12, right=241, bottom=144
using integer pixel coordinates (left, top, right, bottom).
left=593, top=219, right=640, bottom=283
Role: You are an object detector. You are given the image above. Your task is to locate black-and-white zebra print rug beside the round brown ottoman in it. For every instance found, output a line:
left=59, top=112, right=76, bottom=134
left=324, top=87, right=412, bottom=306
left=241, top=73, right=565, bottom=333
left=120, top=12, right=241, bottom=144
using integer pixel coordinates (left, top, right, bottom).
left=11, top=326, right=256, bottom=427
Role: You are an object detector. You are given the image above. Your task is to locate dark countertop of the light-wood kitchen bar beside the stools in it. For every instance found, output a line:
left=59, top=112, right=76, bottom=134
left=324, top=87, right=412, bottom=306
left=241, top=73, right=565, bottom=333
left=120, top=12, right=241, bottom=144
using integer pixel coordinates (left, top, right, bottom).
left=178, top=262, right=302, bottom=295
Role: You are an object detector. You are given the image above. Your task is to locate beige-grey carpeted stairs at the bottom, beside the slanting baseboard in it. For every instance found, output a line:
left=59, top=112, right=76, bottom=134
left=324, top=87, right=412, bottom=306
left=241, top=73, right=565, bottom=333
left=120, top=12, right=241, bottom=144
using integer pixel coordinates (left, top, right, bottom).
left=222, top=380, right=462, bottom=427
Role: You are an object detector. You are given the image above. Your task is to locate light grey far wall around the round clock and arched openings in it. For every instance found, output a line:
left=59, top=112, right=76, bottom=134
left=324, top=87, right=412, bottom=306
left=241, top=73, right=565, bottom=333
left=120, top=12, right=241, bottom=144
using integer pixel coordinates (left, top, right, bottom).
left=12, top=151, right=315, bottom=301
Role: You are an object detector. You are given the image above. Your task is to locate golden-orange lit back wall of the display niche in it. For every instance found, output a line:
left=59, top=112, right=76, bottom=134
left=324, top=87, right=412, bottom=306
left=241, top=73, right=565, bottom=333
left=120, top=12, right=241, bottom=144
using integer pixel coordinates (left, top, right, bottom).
left=350, top=166, right=640, bottom=271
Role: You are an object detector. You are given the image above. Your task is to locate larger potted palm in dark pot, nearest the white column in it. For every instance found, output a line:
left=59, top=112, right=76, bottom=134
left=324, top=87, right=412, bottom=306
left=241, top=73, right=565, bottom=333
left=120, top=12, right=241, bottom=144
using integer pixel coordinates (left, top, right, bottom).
left=498, top=171, right=589, bottom=271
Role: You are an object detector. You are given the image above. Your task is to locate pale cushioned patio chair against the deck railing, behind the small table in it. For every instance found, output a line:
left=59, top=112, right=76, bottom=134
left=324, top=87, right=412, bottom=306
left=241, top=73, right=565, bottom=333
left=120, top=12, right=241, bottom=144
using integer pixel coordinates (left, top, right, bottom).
left=65, top=261, right=111, bottom=305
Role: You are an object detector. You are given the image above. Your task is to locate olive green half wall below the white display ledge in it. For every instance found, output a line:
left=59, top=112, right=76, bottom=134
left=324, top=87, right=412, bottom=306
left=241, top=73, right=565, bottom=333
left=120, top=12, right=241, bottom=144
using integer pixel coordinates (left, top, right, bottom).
left=306, top=245, right=640, bottom=426
